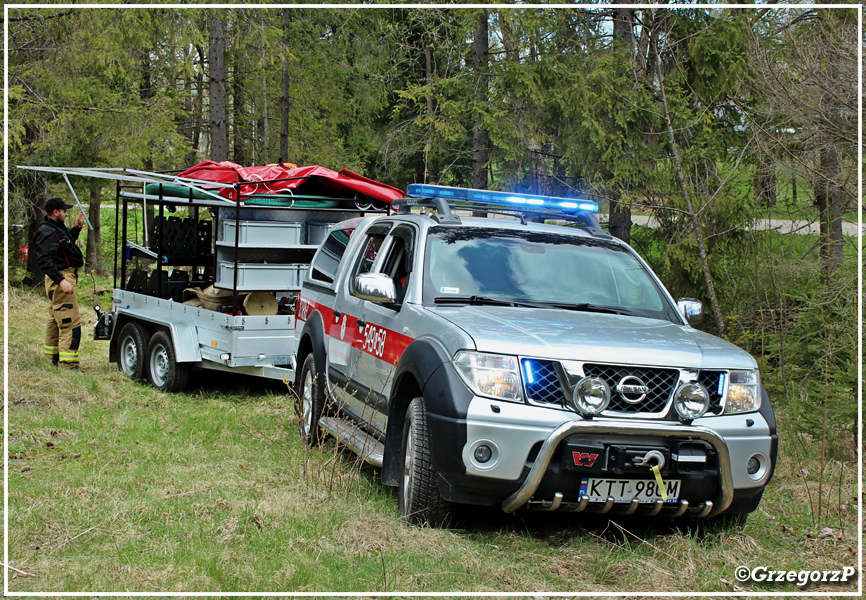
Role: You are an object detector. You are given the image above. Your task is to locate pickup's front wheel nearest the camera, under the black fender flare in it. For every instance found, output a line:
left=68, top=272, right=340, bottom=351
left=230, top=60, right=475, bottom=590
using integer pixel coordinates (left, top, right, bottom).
left=399, top=398, right=451, bottom=525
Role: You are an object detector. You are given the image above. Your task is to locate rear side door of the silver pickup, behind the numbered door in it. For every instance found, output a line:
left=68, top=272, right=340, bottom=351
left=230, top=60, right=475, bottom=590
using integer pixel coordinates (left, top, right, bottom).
left=328, top=223, right=393, bottom=418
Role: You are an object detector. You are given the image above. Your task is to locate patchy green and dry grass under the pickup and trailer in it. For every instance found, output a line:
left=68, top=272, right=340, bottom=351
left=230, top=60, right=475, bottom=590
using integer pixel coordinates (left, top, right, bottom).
left=7, top=286, right=857, bottom=594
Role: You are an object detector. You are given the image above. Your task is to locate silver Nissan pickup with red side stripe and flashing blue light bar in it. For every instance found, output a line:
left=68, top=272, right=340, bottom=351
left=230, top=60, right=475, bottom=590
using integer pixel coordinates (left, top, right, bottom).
left=293, top=185, right=778, bottom=523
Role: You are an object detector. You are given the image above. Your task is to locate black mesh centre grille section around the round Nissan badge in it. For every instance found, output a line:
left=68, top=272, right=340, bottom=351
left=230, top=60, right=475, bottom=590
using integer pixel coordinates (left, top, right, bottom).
left=583, top=363, right=680, bottom=414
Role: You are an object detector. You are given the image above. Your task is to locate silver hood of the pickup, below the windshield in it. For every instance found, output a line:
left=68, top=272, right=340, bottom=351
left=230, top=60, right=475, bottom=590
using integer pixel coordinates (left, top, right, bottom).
left=428, top=306, right=757, bottom=369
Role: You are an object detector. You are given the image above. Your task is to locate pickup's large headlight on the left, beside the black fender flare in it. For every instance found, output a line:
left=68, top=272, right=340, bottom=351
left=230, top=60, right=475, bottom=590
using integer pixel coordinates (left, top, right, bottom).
left=454, top=350, right=523, bottom=402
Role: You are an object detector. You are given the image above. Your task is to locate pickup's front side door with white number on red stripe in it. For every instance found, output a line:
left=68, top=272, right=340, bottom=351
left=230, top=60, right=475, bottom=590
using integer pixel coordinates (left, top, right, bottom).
left=355, top=224, right=417, bottom=432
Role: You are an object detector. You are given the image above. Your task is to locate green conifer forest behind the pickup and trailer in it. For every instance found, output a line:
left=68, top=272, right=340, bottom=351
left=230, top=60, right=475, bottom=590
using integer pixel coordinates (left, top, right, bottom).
left=4, top=4, right=862, bottom=596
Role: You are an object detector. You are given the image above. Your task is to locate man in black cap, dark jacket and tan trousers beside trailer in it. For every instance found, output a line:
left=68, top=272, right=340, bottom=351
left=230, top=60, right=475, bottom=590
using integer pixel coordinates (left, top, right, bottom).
left=33, top=198, right=84, bottom=373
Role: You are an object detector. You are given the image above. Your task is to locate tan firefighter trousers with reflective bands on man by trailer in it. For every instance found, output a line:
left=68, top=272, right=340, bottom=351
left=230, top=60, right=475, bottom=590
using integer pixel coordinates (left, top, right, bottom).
left=44, top=269, right=81, bottom=369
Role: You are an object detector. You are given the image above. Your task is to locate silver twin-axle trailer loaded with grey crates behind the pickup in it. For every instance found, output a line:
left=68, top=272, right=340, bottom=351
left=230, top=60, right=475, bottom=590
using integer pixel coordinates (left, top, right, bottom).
left=22, top=163, right=394, bottom=391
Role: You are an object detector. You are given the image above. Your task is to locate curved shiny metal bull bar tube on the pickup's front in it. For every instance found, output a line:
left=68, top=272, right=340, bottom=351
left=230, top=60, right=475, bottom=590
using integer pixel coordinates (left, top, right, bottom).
left=502, top=419, right=734, bottom=517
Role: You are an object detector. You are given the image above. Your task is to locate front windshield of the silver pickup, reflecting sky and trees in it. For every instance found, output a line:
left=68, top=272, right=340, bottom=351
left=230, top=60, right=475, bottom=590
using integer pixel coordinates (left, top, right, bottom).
left=424, top=227, right=680, bottom=323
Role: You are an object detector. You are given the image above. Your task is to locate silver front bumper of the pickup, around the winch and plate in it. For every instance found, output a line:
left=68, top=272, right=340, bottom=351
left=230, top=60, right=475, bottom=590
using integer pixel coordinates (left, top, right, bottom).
left=434, top=397, right=775, bottom=517
